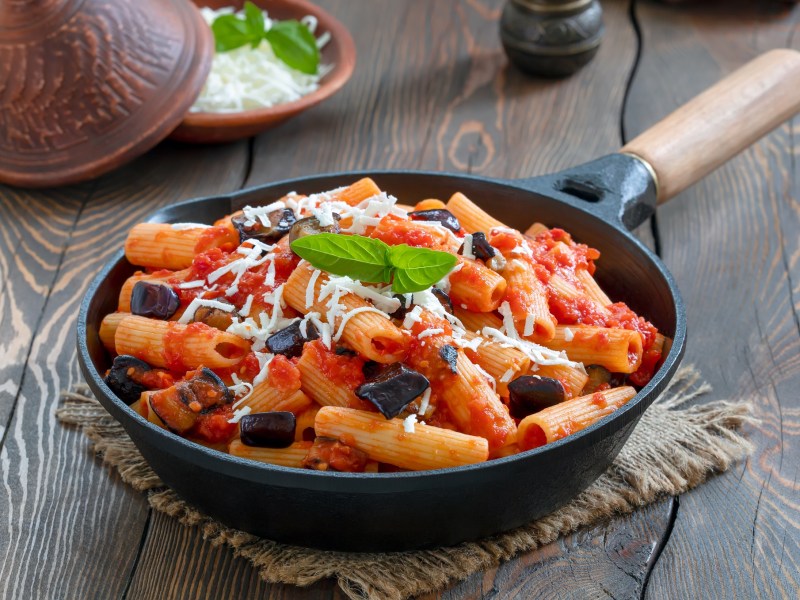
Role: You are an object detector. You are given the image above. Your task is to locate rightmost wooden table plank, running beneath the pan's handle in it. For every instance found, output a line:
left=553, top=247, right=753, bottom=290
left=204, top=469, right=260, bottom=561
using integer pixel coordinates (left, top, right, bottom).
left=625, top=2, right=800, bottom=598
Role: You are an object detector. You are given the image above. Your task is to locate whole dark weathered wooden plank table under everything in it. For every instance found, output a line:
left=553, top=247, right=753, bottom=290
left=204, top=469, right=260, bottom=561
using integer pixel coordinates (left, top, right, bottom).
left=0, top=0, right=800, bottom=600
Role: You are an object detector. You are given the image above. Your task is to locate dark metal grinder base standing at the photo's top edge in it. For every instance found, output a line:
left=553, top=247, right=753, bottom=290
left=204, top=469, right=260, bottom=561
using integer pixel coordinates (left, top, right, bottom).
left=500, top=0, right=604, bottom=77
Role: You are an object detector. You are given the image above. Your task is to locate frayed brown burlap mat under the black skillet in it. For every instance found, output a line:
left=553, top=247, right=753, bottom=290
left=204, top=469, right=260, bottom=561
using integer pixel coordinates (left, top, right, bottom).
left=57, top=367, right=753, bottom=600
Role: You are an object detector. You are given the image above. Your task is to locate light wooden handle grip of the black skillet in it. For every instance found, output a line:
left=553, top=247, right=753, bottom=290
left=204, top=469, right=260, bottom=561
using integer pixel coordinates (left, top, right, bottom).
left=621, top=49, right=800, bottom=204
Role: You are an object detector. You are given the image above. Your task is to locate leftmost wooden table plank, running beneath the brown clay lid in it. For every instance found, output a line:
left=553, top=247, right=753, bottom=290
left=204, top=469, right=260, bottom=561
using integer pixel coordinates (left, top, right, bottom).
left=0, top=143, right=247, bottom=598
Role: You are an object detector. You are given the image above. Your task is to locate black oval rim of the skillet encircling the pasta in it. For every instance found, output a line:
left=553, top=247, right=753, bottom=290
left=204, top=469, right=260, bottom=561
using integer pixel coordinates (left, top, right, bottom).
left=77, top=169, right=686, bottom=494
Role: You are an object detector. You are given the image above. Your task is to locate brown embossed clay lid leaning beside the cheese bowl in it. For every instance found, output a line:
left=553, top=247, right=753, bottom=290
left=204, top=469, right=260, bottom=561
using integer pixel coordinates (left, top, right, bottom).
left=0, top=0, right=214, bottom=187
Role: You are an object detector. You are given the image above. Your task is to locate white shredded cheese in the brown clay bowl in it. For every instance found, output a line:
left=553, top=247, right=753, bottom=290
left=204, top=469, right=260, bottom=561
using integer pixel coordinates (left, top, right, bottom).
left=190, top=7, right=333, bottom=113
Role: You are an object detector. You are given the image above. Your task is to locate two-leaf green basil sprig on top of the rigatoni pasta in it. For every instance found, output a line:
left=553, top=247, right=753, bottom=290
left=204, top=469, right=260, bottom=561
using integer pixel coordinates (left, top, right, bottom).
left=292, top=233, right=458, bottom=294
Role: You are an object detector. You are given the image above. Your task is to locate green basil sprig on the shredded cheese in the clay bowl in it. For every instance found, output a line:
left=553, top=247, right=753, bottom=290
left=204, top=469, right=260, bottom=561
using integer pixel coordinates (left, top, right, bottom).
left=211, top=2, right=319, bottom=75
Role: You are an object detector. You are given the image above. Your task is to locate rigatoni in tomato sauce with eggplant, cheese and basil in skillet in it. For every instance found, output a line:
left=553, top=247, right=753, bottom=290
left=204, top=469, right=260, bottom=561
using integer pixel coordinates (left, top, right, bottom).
left=98, top=178, right=669, bottom=472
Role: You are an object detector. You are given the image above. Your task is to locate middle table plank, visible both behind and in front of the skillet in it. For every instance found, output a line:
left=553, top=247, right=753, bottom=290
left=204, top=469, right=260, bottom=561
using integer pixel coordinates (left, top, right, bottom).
left=123, top=0, right=672, bottom=600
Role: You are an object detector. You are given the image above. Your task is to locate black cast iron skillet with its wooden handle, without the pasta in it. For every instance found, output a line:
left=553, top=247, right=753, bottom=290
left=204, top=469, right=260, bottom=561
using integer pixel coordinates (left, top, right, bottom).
left=78, top=51, right=800, bottom=551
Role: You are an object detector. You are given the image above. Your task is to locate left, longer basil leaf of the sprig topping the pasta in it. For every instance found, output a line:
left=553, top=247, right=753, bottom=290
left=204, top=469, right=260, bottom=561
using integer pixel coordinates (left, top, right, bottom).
left=292, top=233, right=392, bottom=283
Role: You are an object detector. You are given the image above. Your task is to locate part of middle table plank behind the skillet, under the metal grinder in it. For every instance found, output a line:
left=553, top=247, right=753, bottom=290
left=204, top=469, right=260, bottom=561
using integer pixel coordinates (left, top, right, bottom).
left=248, top=0, right=636, bottom=184
